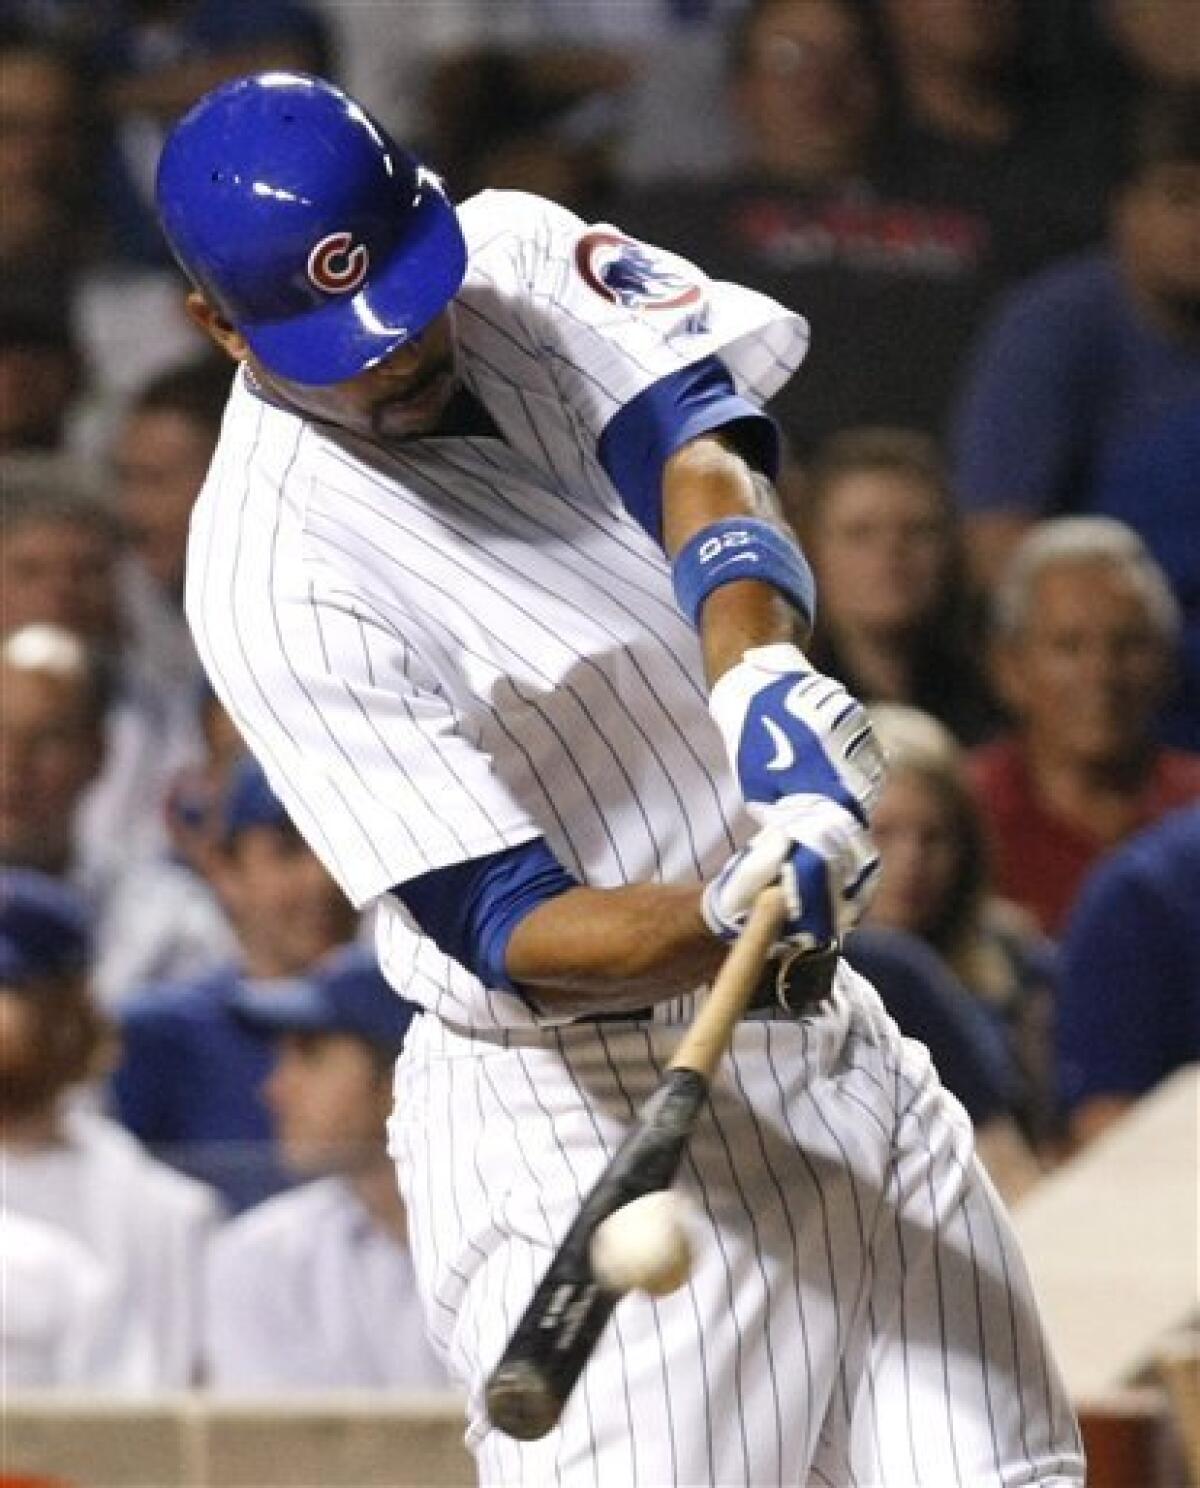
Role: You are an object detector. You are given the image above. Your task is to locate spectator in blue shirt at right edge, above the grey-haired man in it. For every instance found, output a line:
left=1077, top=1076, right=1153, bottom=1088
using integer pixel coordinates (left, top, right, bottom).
left=953, top=86, right=1200, bottom=747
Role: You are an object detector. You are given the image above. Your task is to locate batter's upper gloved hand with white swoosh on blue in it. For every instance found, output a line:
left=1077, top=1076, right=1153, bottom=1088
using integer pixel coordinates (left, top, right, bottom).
left=709, top=644, right=884, bottom=826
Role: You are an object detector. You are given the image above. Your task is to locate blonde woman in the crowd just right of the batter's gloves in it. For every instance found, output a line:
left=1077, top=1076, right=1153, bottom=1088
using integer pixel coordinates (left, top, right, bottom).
left=867, top=704, right=1056, bottom=1147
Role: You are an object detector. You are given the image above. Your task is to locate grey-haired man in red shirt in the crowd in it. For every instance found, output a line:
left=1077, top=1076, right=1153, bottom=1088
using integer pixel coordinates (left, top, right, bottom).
left=971, top=516, right=1200, bottom=936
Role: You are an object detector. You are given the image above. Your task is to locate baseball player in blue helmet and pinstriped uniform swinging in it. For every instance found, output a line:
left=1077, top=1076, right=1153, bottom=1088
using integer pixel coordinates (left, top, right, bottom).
left=158, top=73, right=1082, bottom=1488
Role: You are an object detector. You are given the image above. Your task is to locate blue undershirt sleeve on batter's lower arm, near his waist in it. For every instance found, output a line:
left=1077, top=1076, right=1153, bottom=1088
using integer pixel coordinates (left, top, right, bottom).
left=392, top=838, right=578, bottom=992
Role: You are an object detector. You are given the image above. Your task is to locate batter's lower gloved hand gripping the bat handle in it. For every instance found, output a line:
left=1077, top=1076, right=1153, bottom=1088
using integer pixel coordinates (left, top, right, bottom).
left=701, top=796, right=880, bottom=949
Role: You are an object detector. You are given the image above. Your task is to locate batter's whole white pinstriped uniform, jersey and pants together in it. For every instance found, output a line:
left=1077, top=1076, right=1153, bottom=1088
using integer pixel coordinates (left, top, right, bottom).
left=188, top=193, right=1081, bottom=1488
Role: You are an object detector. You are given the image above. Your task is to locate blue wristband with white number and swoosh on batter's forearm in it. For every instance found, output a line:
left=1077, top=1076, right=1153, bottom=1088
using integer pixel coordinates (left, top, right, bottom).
left=671, top=516, right=817, bottom=625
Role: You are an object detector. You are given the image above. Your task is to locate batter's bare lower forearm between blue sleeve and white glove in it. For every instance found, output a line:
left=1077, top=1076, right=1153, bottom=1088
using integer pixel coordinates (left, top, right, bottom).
left=506, top=884, right=725, bottom=1013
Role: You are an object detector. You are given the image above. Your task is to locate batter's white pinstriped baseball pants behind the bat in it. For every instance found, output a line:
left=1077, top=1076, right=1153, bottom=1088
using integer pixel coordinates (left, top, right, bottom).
left=392, top=972, right=1082, bottom=1488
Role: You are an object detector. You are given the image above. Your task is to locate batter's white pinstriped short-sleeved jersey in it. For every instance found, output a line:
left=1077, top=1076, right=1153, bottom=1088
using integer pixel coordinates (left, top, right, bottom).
left=188, top=192, right=807, bottom=1027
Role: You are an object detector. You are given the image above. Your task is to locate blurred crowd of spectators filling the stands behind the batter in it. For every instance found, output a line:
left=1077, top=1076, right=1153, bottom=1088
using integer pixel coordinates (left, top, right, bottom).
left=0, top=0, right=1200, bottom=1391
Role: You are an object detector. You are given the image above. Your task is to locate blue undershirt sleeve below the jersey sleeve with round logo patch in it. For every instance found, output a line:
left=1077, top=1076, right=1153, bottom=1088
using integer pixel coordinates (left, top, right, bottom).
left=597, top=357, right=780, bottom=543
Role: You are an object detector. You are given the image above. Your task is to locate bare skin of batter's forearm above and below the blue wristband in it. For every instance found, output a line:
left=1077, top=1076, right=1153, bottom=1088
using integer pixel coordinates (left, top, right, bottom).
left=663, top=436, right=808, bottom=686
